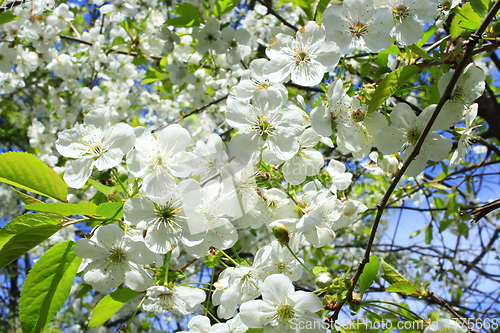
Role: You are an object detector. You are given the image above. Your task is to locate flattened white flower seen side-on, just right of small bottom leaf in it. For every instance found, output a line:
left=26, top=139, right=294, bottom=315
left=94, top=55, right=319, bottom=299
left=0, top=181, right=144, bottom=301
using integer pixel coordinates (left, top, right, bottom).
left=142, top=286, right=206, bottom=315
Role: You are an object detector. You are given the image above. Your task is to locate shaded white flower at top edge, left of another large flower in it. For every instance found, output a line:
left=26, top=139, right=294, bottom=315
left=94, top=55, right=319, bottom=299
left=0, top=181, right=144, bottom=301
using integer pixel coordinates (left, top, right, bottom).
left=322, top=0, right=392, bottom=54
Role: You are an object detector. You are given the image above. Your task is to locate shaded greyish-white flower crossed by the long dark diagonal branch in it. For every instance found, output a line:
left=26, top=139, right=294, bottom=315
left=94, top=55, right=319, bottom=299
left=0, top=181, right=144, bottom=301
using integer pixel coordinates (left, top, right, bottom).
left=375, top=104, right=452, bottom=177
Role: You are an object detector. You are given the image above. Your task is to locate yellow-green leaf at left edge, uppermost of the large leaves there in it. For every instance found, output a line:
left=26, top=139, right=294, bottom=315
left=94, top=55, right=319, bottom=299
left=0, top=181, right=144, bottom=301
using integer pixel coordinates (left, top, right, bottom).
left=0, top=151, right=68, bottom=202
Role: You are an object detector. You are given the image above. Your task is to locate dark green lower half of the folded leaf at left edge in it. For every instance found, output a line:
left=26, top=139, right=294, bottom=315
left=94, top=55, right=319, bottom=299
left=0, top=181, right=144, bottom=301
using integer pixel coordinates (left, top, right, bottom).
left=0, top=222, right=61, bottom=269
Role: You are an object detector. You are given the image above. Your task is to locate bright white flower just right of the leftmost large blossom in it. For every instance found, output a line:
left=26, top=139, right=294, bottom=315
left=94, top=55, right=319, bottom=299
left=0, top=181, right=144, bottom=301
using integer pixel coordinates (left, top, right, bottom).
left=127, top=124, right=198, bottom=197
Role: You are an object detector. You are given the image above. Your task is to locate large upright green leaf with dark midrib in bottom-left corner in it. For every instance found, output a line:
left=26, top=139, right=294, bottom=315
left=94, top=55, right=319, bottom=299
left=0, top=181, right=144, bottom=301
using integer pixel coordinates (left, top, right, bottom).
left=19, top=241, right=82, bottom=333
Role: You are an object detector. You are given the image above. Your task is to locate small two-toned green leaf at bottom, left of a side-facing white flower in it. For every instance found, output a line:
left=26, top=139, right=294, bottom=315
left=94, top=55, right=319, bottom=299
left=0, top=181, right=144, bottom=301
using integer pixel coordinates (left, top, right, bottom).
left=89, top=289, right=141, bottom=327
